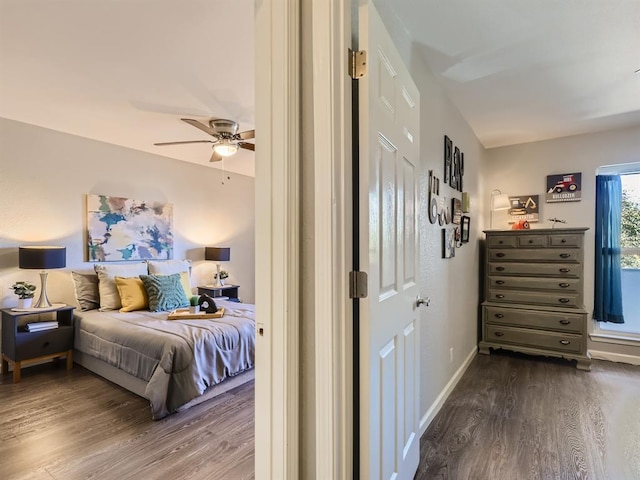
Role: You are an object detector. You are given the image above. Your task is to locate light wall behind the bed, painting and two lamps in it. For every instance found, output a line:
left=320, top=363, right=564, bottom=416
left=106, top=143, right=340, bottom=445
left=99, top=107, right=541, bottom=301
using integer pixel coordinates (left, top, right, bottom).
left=0, top=119, right=255, bottom=307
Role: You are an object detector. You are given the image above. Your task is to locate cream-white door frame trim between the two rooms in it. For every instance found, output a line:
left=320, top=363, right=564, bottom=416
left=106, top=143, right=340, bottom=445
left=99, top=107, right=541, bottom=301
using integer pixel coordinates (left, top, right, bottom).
left=255, top=0, right=357, bottom=480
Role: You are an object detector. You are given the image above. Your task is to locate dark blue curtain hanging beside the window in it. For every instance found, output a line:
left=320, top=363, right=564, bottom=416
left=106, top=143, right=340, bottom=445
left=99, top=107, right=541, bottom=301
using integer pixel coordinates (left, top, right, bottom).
left=593, top=175, right=624, bottom=323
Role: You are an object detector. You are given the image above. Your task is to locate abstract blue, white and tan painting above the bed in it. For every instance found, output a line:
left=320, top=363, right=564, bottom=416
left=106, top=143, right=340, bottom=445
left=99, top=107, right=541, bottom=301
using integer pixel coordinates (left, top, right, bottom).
left=87, top=195, right=173, bottom=262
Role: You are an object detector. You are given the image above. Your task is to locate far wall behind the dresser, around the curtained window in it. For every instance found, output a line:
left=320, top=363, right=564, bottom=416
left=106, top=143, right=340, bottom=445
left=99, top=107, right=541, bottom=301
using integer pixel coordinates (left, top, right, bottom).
left=482, top=127, right=640, bottom=356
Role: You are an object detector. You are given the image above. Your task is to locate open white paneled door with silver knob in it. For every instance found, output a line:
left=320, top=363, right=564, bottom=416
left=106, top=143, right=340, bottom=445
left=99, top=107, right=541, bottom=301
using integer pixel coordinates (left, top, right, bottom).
left=358, top=4, right=420, bottom=480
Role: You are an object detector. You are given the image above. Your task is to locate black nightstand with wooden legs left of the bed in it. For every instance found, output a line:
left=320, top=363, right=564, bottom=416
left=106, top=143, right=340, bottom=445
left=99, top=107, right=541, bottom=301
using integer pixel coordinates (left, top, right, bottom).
left=2, top=306, right=75, bottom=383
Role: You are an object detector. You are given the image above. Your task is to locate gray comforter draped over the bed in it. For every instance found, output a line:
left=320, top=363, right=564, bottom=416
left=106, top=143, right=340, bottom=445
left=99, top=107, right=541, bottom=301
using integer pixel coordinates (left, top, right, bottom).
left=75, top=301, right=255, bottom=419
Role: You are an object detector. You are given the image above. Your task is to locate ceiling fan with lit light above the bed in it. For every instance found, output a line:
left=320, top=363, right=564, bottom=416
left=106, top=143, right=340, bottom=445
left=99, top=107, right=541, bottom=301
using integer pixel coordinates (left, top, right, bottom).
left=154, top=118, right=256, bottom=162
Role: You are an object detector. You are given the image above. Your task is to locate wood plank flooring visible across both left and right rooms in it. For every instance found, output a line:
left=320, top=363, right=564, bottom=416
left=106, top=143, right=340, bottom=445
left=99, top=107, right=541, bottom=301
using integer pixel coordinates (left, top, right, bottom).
left=0, top=353, right=640, bottom=480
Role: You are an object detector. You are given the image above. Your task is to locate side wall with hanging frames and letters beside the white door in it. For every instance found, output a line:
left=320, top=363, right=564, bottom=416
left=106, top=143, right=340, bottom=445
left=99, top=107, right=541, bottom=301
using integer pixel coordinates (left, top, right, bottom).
left=377, top=4, right=484, bottom=428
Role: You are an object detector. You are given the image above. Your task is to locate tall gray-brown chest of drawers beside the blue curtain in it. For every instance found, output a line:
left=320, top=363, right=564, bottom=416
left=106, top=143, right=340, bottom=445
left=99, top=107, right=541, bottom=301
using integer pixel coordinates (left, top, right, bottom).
left=479, top=228, right=591, bottom=370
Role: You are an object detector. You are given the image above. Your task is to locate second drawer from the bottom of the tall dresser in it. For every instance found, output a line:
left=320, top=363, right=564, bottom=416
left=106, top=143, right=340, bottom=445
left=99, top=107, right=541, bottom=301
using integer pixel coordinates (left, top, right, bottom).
left=484, top=307, right=586, bottom=333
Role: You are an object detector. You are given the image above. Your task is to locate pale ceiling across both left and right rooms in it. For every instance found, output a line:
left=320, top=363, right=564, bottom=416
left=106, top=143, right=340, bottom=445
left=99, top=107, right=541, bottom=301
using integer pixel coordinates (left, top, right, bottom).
left=0, top=0, right=640, bottom=175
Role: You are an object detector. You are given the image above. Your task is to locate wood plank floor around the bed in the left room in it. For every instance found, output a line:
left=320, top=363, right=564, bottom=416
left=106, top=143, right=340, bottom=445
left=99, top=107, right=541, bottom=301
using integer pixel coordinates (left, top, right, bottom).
left=0, top=363, right=254, bottom=480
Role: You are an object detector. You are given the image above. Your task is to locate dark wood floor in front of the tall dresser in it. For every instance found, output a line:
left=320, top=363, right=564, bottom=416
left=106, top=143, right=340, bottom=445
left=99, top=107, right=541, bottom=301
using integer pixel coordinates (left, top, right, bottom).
left=415, top=352, right=640, bottom=480
